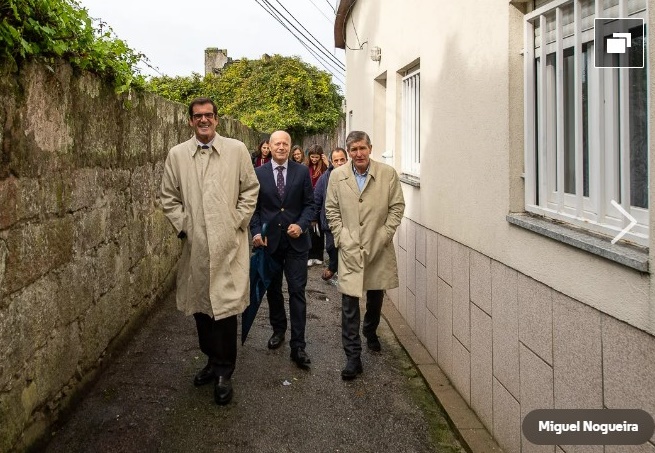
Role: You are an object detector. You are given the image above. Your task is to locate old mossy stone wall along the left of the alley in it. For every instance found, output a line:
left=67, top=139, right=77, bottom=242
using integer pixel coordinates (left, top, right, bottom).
left=0, top=64, right=258, bottom=451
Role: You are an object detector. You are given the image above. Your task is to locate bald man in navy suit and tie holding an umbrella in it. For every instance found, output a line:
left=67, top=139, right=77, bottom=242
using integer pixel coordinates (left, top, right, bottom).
left=250, top=131, right=314, bottom=368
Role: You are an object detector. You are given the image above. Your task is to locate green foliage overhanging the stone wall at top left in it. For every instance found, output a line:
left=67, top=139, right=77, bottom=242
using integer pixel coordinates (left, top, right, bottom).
left=0, top=0, right=147, bottom=92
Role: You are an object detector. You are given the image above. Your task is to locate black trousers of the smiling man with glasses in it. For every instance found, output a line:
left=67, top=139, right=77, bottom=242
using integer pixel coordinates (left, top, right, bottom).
left=193, top=313, right=238, bottom=379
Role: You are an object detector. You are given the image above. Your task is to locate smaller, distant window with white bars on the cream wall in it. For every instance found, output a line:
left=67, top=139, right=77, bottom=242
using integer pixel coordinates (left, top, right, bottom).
left=401, top=66, right=421, bottom=177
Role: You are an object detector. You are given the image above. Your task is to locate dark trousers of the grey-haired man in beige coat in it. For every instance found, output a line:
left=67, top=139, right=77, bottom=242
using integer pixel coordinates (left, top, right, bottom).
left=341, top=289, right=384, bottom=359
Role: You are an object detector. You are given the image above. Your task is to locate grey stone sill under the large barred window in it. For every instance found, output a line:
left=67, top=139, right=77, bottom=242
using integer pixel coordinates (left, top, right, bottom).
left=506, top=213, right=648, bottom=272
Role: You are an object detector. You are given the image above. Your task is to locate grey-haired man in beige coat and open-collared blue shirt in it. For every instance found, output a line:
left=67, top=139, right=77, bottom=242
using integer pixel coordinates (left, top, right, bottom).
left=325, top=131, right=405, bottom=380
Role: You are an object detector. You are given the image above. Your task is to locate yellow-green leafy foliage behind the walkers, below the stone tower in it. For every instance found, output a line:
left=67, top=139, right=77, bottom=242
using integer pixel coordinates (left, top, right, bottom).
left=148, top=55, right=342, bottom=137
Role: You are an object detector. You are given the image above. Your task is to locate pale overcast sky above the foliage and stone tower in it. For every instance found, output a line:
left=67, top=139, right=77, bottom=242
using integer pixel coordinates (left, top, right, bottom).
left=78, top=0, right=345, bottom=88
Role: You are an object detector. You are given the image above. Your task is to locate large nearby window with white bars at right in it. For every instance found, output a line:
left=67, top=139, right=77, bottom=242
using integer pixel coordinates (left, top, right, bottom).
left=524, top=0, right=649, bottom=246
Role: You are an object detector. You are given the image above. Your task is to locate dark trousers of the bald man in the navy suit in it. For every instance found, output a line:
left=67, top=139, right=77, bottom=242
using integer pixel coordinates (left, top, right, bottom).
left=266, top=235, right=307, bottom=349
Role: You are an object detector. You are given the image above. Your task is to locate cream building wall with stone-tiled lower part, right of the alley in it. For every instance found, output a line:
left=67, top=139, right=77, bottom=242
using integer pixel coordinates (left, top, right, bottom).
left=346, top=0, right=655, bottom=452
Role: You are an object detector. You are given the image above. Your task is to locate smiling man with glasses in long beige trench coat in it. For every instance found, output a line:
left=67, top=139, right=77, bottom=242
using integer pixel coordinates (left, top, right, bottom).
left=161, top=98, right=259, bottom=405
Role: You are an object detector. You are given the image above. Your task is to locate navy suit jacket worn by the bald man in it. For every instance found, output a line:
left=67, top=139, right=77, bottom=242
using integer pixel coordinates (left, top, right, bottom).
left=250, top=160, right=314, bottom=254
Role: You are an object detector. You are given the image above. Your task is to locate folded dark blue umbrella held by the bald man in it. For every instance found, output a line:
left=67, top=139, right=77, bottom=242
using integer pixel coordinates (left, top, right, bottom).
left=241, top=224, right=280, bottom=345
